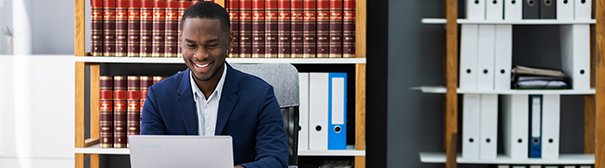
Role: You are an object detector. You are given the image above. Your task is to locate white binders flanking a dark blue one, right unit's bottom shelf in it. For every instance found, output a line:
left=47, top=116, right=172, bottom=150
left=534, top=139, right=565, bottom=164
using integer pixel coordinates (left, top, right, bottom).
left=502, top=95, right=560, bottom=159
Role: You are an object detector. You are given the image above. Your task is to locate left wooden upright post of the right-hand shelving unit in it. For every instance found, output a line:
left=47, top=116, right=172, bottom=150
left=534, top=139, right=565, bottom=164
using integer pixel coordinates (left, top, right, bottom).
left=444, top=0, right=458, bottom=168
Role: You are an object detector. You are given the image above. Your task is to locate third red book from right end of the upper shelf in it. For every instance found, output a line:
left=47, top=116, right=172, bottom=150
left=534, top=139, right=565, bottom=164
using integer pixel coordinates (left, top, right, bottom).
left=316, top=0, right=330, bottom=58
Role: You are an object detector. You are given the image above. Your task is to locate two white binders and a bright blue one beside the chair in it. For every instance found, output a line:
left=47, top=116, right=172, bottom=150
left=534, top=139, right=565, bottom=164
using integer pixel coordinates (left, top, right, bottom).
left=298, top=72, right=347, bottom=151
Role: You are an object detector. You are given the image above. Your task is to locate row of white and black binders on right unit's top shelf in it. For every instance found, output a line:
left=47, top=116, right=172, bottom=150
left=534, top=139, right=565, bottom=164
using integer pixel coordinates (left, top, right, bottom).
left=466, top=0, right=592, bottom=21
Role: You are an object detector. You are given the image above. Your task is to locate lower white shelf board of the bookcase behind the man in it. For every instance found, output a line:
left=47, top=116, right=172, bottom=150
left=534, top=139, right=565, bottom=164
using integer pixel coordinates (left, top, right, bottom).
left=74, top=144, right=366, bottom=156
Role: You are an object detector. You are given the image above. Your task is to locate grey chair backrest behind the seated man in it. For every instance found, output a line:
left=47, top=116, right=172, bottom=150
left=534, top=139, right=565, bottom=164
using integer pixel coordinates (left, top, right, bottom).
left=230, top=63, right=300, bottom=165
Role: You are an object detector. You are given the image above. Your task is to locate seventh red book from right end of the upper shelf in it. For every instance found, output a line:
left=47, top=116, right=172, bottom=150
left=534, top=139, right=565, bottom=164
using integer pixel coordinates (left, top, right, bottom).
left=265, top=0, right=279, bottom=58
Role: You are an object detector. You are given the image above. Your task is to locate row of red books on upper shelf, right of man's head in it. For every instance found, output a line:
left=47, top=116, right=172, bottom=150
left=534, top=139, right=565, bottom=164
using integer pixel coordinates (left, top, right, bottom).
left=226, top=0, right=356, bottom=58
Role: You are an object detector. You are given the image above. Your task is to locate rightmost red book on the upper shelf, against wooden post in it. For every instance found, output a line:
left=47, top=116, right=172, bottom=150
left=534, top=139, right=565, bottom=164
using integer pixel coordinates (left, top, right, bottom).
left=342, top=0, right=356, bottom=58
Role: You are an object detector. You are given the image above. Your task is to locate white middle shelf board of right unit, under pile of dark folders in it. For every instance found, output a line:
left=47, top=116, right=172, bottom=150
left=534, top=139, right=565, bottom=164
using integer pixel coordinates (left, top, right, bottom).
left=411, top=86, right=596, bottom=95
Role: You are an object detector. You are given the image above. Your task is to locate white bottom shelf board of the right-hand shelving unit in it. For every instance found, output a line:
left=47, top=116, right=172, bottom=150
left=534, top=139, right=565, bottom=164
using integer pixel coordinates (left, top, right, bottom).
left=419, top=152, right=594, bottom=165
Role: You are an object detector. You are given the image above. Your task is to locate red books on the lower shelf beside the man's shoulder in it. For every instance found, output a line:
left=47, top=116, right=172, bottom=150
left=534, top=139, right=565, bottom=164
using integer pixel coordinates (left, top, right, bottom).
left=99, top=76, right=164, bottom=148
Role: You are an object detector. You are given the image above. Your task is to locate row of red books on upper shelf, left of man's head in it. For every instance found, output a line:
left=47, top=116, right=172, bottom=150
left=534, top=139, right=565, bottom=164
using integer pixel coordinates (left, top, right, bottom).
left=90, top=0, right=212, bottom=57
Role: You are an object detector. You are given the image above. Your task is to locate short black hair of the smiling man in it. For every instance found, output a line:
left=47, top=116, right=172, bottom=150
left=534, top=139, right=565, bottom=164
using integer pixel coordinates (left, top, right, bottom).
left=181, top=1, right=231, bottom=32
